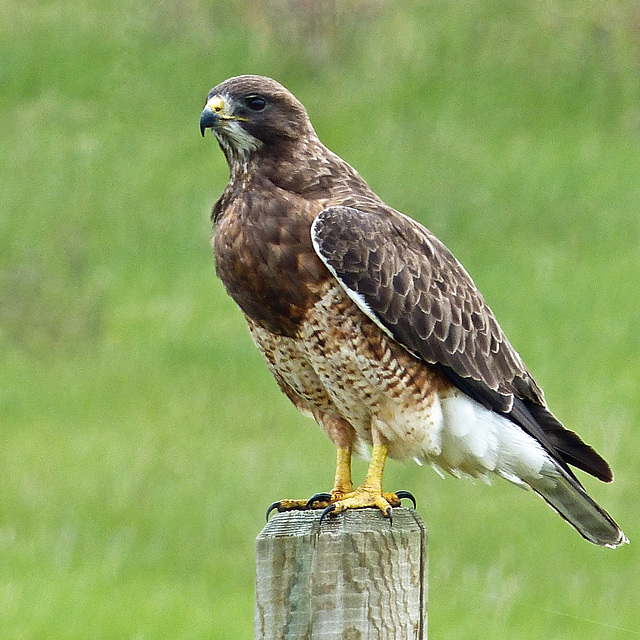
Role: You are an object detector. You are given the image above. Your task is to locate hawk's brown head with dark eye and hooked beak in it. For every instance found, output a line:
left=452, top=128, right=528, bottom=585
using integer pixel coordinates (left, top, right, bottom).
left=200, top=75, right=313, bottom=158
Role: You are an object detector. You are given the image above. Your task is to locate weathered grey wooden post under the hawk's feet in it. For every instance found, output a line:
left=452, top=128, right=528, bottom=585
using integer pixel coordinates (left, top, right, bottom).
left=255, top=509, right=427, bottom=640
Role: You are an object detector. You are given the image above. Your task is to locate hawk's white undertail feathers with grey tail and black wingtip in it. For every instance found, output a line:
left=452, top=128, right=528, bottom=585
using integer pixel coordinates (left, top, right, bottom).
left=436, top=394, right=628, bottom=547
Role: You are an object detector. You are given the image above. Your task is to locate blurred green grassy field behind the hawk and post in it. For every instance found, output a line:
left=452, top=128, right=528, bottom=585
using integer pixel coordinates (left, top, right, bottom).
left=0, top=0, right=640, bottom=640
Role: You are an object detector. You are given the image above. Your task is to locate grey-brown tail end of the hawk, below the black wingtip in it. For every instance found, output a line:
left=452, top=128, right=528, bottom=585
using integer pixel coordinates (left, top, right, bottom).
left=527, top=463, right=629, bottom=548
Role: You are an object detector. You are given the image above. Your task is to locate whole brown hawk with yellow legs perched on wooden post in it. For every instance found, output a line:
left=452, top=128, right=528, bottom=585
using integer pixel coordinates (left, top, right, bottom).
left=200, top=75, right=626, bottom=547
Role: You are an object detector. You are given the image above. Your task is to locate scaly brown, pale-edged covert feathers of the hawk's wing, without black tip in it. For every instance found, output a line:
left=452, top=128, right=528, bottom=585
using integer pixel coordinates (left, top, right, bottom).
left=312, top=207, right=528, bottom=400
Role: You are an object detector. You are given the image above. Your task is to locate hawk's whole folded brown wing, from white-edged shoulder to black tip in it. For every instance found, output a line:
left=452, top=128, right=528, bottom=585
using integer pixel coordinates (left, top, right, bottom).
left=311, top=205, right=612, bottom=481
